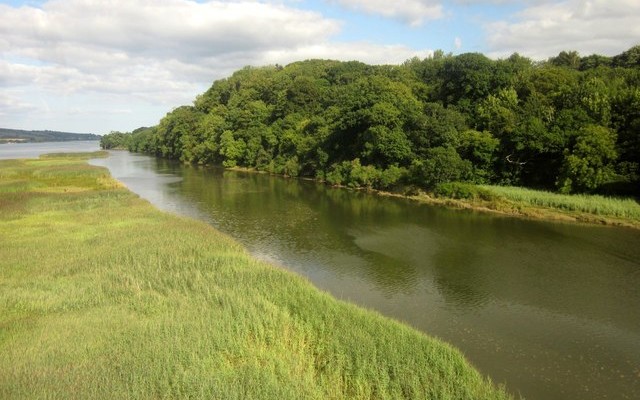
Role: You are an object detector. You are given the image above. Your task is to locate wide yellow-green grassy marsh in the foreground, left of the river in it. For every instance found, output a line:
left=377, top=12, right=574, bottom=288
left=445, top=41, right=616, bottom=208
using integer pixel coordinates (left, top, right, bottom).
left=0, top=156, right=508, bottom=399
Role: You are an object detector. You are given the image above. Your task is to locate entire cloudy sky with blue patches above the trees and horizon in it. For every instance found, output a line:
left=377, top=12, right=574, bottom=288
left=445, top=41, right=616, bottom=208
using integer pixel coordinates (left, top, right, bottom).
left=0, top=0, right=640, bottom=134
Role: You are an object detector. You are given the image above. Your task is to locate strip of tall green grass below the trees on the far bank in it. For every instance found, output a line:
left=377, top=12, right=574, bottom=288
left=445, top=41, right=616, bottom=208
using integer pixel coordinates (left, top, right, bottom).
left=479, top=185, right=640, bottom=221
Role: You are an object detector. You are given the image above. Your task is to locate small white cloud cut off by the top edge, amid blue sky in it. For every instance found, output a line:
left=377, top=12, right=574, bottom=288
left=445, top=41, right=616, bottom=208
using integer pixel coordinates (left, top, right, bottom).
left=329, top=0, right=444, bottom=26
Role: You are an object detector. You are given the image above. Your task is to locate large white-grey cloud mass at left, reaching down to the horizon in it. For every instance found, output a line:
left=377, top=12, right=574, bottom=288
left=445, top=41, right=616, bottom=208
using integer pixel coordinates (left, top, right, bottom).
left=0, top=0, right=432, bottom=132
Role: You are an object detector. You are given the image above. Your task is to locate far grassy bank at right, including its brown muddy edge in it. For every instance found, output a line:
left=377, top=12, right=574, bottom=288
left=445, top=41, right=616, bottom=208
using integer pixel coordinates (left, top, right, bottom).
left=409, top=182, right=640, bottom=229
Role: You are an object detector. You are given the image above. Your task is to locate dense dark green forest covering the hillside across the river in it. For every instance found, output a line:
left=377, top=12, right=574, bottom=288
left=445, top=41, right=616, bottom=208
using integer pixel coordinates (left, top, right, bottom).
left=102, top=46, right=640, bottom=194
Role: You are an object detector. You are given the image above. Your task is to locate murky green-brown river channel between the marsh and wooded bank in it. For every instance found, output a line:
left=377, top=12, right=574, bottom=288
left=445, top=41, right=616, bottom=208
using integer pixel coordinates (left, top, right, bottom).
left=0, top=142, right=640, bottom=399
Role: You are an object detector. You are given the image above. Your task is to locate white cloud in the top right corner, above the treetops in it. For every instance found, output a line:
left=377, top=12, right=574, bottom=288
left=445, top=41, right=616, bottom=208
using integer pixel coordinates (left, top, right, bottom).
left=486, top=0, right=640, bottom=60
